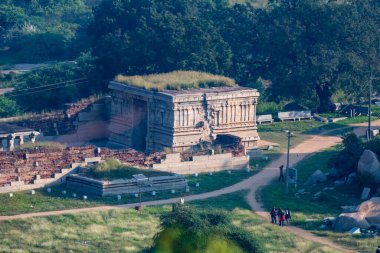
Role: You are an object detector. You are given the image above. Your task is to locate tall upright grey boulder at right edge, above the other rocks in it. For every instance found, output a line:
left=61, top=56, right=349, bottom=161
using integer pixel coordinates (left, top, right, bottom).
left=358, top=149, right=380, bottom=184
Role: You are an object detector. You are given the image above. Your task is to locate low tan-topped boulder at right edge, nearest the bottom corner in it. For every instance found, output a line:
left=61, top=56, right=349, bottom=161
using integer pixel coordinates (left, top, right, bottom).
left=333, top=198, right=380, bottom=232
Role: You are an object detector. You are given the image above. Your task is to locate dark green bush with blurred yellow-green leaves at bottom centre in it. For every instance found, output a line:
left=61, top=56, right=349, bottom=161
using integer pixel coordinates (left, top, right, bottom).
left=150, top=205, right=263, bottom=253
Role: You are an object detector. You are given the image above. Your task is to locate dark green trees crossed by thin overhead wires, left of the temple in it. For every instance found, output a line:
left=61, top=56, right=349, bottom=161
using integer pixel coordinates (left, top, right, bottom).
left=6, top=54, right=97, bottom=111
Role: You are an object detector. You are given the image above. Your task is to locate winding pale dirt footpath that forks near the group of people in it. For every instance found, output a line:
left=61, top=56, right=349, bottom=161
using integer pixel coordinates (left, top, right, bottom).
left=0, top=120, right=380, bottom=253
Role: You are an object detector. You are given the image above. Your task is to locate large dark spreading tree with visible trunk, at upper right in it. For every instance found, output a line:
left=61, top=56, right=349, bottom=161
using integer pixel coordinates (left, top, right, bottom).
left=252, top=0, right=380, bottom=112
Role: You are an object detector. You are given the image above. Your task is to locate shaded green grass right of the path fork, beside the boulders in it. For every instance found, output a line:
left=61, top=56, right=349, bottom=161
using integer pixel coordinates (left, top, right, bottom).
left=258, top=146, right=380, bottom=253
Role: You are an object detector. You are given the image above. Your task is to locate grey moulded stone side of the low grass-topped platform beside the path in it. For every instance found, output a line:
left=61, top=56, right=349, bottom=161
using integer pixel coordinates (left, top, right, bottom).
left=66, top=175, right=187, bottom=196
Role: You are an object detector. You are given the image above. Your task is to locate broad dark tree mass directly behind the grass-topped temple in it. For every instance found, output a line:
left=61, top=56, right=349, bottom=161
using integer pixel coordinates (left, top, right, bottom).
left=89, top=0, right=231, bottom=89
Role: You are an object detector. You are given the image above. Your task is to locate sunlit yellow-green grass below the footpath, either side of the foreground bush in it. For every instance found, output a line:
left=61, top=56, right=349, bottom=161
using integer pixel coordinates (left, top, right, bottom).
left=0, top=191, right=336, bottom=253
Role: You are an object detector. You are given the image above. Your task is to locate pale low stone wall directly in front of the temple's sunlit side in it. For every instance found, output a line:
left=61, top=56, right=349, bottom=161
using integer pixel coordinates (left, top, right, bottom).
left=153, top=153, right=249, bottom=174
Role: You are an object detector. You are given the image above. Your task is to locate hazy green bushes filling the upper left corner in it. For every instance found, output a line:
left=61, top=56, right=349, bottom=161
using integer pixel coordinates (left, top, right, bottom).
left=0, top=0, right=92, bottom=64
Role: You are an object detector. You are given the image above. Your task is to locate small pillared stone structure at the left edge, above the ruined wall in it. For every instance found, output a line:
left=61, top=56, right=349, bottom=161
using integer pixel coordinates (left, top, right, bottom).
left=0, top=123, right=39, bottom=151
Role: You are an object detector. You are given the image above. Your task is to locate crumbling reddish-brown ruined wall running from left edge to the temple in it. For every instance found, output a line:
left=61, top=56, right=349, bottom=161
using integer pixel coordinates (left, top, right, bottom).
left=0, top=146, right=164, bottom=187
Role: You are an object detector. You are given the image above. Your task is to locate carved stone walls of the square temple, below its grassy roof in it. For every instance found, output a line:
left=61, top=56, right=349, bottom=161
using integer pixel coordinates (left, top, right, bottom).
left=109, top=82, right=259, bottom=152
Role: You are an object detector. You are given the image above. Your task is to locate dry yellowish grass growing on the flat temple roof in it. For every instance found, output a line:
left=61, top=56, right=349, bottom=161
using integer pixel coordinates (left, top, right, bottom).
left=115, top=71, right=236, bottom=91
